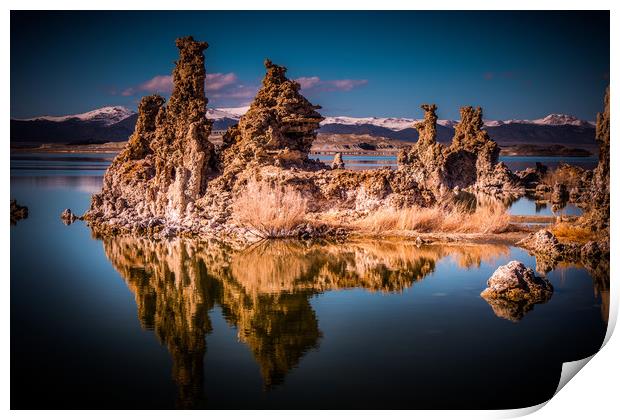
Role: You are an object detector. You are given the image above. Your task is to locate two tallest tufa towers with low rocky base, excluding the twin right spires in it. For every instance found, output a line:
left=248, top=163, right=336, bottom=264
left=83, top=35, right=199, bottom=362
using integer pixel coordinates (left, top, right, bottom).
left=84, top=37, right=435, bottom=239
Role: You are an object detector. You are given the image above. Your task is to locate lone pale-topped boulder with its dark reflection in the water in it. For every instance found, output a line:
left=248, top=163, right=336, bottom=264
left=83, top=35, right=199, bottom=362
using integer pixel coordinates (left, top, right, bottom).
left=480, top=261, right=553, bottom=321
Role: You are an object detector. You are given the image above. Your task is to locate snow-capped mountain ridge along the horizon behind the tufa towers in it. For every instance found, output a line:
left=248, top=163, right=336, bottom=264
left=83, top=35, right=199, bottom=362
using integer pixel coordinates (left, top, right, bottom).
left=11, top=106, right=595, bottom=146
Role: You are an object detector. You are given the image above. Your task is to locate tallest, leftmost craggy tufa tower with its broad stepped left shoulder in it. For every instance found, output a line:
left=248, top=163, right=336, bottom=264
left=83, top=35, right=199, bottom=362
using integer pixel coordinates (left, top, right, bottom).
left=85, top=37, right=215, bottom=228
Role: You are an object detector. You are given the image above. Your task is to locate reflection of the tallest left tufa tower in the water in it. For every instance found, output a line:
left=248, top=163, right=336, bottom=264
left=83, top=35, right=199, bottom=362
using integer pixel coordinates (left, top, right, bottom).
left=104, top=238, right=214, bottom=408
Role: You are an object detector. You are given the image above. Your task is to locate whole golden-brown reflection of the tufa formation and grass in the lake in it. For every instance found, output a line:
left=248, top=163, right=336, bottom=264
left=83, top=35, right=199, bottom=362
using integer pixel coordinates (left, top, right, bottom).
left=103, top=237, right=508, bottom=407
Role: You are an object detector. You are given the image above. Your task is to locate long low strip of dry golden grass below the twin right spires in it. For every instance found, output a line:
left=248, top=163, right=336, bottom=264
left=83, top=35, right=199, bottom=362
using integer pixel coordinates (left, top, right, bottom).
left=356, top=203, right=510, bottom=233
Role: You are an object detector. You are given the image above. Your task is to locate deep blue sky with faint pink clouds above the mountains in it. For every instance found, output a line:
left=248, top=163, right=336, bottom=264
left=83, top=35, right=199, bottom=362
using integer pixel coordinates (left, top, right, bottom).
left=11, top=11, right=609, bottom=120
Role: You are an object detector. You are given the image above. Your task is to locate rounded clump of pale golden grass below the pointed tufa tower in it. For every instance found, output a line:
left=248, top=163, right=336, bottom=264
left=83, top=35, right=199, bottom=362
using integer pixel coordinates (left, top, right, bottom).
left=233, top=181, right=307, bottom=239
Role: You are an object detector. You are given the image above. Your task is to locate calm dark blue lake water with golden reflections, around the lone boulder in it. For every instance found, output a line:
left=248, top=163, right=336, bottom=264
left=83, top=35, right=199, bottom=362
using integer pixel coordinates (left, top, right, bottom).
left=10, top=155, right=609, bottom=409
